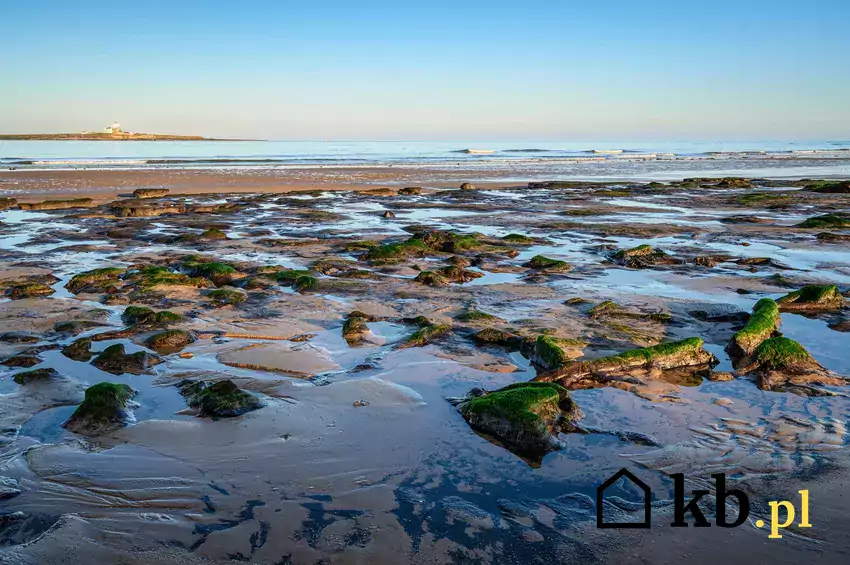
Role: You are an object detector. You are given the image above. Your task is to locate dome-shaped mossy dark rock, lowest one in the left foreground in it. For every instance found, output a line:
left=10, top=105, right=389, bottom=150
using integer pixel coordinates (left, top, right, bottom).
left=64, top=382, right=136, bottom=435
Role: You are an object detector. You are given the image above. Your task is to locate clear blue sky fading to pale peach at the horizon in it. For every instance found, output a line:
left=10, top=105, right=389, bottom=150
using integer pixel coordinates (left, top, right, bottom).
left=0, top=0, right=850, bottom=140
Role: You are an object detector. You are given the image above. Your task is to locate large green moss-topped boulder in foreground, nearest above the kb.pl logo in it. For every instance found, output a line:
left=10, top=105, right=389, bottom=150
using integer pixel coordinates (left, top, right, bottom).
left=450, top=382, right=582, bottom=458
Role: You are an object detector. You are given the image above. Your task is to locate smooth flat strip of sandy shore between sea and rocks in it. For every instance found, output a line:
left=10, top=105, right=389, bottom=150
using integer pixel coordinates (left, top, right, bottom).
left=0, top=158, right=850, bottom=201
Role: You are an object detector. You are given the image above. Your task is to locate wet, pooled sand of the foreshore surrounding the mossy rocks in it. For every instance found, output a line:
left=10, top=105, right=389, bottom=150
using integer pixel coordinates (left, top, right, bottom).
left=0, top=170, right=850, bottom=564
